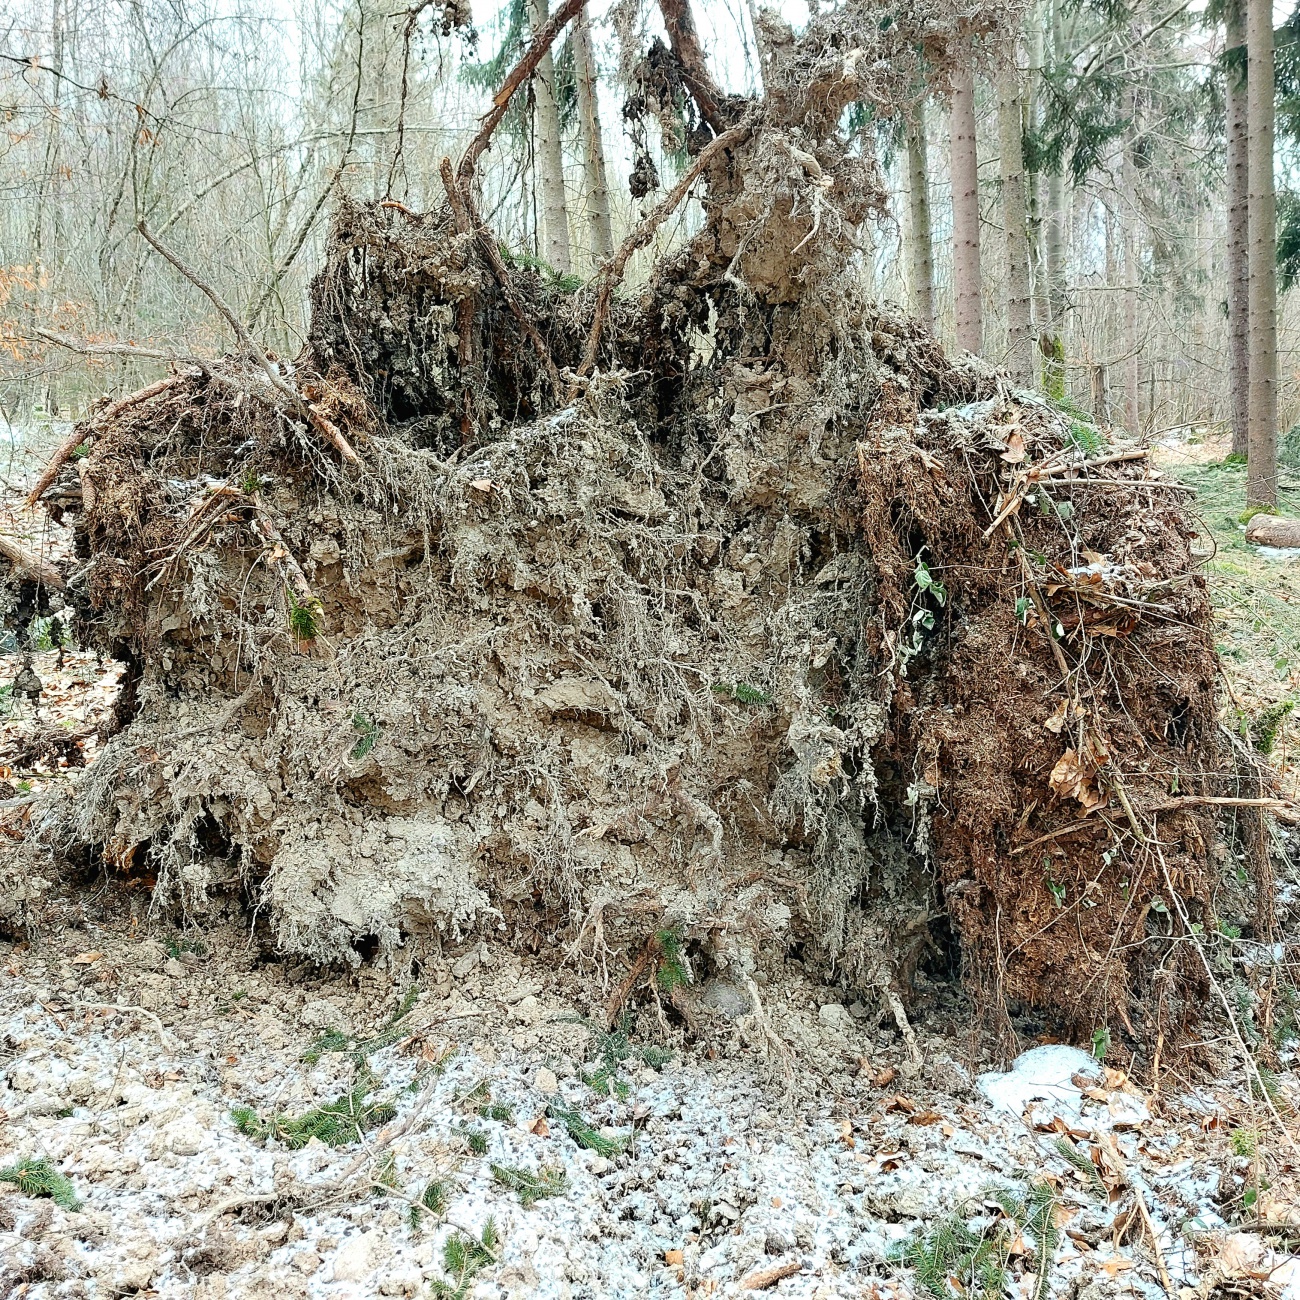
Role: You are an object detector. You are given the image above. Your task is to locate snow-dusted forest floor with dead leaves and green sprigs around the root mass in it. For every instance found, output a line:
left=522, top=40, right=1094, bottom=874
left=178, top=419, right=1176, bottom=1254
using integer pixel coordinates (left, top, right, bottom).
left=0, top=428, right=1300, bottom=1300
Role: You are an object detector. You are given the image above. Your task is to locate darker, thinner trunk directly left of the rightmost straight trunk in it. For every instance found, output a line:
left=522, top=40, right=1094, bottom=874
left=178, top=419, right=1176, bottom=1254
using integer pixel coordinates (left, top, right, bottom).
left=1223, top=0, right=1251, bottom=456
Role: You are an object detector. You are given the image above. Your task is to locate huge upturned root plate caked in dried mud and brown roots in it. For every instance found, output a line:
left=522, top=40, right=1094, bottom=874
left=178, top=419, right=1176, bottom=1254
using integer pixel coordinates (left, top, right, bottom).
left=7, top=0, right=1248, bottom=1041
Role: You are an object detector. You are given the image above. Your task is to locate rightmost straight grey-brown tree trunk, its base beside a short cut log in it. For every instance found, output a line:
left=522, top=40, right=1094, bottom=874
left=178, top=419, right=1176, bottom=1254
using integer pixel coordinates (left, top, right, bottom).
left=1245, top=0, right=1278, bottom=507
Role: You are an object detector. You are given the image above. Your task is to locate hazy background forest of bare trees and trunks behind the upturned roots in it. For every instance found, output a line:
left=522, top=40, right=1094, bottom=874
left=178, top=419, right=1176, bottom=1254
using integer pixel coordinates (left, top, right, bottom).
left=0, top=0, right=1300, bottom=475
